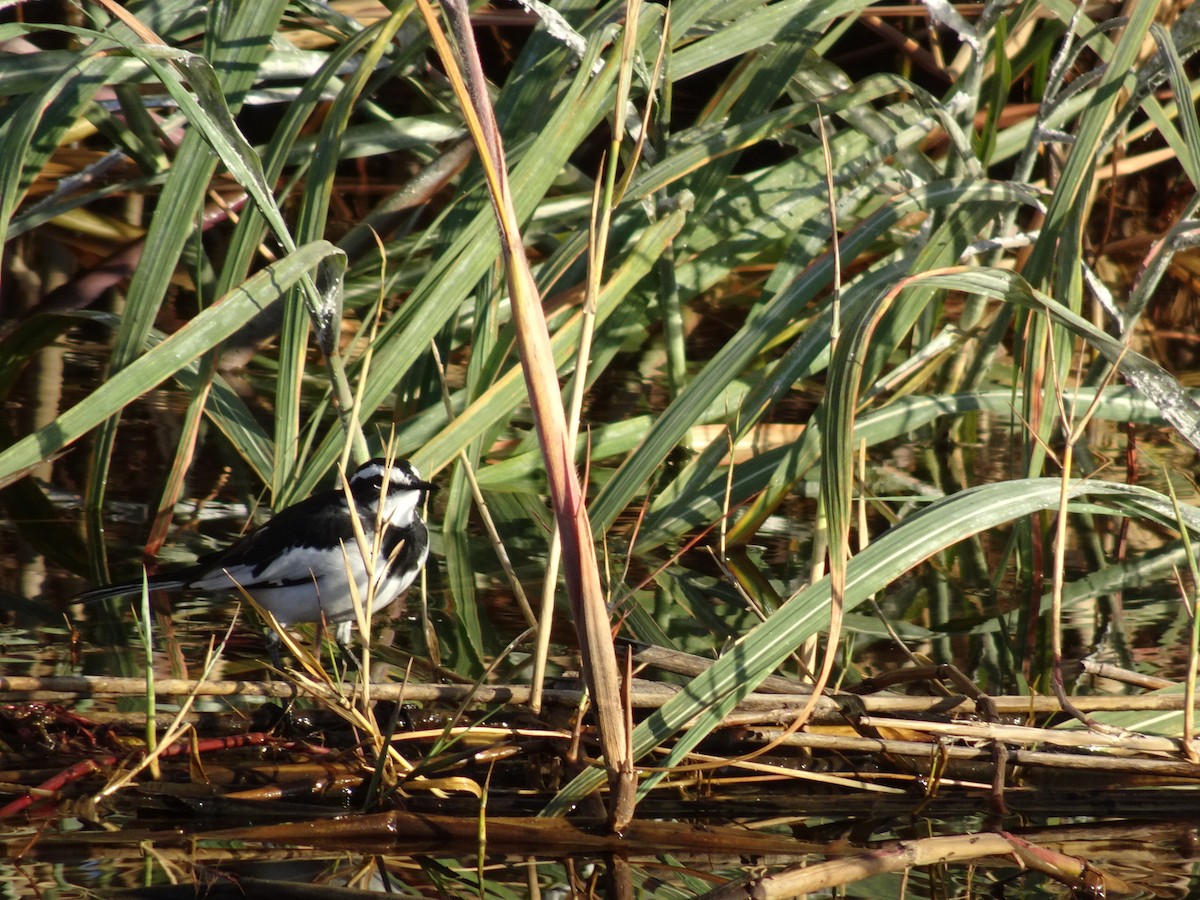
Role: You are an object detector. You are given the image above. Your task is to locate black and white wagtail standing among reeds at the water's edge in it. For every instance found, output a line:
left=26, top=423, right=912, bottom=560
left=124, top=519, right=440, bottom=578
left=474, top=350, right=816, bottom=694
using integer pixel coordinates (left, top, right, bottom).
left=79, top=458, right=436, bottom=664
